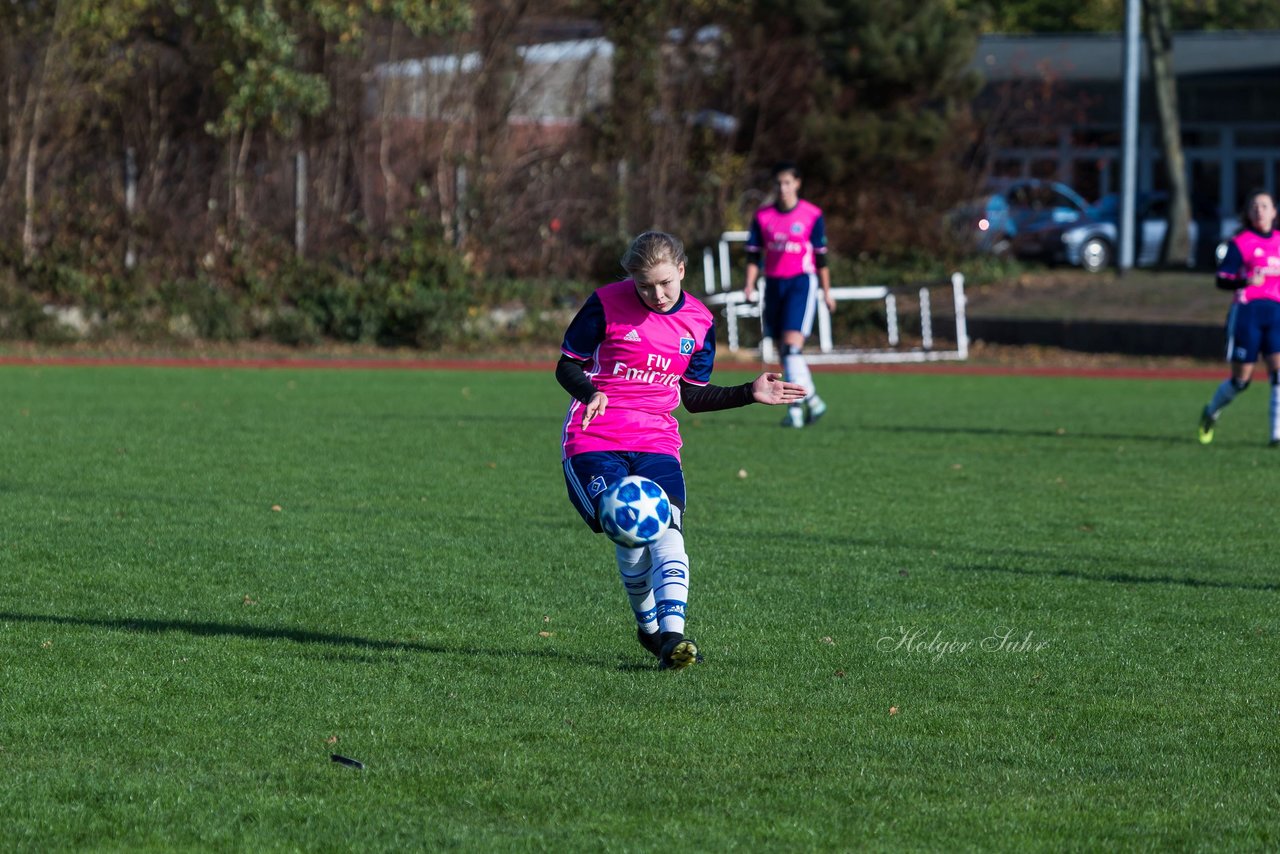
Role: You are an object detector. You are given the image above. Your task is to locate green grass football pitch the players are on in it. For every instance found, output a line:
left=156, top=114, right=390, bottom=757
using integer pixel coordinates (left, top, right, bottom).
left=0, top=367, right=1280, bottom=851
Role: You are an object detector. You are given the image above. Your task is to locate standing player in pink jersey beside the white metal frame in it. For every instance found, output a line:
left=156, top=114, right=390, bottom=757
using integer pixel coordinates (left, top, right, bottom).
left=742, top=163, right=836, bottom=428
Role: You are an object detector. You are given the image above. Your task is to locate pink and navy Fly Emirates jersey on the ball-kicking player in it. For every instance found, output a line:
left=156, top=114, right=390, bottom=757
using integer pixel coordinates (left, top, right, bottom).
left=561, top=279, right=716, bottom=460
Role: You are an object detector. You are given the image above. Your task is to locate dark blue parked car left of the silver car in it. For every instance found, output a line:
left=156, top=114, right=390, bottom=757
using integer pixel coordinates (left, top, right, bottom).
left=950, top=178, right=1089, bottom=255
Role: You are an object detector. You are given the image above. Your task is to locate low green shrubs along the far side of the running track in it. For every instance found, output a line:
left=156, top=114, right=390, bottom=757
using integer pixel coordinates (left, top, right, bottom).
left=0, top=220, right=1018, bottom=351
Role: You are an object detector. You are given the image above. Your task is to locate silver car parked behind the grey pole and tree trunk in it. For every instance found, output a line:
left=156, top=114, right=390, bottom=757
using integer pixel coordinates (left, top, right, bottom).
left=1012, top=192, right=1233, bottom=273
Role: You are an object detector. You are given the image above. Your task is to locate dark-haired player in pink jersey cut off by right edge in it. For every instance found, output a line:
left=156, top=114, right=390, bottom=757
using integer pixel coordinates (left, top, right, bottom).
left=1198, top=189, right=1280, bottom=448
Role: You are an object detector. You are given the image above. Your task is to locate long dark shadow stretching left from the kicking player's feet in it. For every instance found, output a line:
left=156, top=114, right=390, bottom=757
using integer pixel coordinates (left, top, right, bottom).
left=0, top=611, right=602, bottom=665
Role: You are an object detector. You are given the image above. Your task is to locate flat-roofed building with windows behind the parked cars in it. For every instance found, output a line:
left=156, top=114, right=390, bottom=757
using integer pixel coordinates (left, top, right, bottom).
left=972, top=31, right=1280, bottom=216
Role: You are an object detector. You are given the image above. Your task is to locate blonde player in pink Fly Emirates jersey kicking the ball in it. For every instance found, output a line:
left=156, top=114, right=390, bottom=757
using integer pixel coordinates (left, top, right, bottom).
left=556, top=232, right=805, bottom=670
